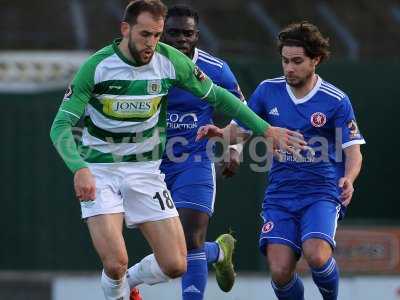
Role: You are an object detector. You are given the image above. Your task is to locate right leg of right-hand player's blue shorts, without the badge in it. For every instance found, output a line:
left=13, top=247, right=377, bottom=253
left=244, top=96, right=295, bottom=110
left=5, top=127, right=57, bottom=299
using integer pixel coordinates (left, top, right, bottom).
left=300, top=201, right=340, bottom=249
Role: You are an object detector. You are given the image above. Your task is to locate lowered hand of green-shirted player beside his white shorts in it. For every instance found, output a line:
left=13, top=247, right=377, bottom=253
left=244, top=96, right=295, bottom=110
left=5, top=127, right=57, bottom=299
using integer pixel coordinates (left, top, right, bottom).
left=74, top=168, right=96, bottom=201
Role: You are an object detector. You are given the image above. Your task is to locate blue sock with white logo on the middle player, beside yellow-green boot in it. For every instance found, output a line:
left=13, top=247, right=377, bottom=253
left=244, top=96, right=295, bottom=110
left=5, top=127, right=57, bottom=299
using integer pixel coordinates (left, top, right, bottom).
left=181, top=246, right=208, bottom=300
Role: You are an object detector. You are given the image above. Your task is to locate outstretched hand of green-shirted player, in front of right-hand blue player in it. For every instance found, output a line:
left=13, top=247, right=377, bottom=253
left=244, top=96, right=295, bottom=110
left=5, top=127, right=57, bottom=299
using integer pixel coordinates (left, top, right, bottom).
left=264, top=126, right=309, bottom=155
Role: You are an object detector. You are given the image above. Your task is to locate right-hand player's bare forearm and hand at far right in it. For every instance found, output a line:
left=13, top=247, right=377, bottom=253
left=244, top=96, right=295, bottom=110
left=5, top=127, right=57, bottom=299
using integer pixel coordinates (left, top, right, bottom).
left=338, top=145, right=362, bottom=206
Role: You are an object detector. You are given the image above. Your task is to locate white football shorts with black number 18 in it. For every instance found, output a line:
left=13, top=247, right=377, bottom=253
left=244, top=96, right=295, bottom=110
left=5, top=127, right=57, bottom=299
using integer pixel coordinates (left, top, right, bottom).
left=81, top=160, right=178, bottom=228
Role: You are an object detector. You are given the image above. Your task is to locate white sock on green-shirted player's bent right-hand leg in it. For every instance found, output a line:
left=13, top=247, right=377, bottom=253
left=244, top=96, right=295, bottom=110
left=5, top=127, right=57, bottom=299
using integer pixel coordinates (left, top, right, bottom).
left=127, top=254, right=170, bottom=289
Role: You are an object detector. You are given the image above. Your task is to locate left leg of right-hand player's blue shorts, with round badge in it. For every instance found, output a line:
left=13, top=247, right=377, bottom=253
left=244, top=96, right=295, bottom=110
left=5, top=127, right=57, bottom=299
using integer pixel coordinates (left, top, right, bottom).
left=259, top=205, right=301, bottom=257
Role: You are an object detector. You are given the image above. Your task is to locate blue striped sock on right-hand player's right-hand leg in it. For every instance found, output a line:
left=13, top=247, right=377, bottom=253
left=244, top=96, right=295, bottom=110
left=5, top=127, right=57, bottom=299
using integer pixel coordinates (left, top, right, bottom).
left=311, top=257, right=339, bottom=300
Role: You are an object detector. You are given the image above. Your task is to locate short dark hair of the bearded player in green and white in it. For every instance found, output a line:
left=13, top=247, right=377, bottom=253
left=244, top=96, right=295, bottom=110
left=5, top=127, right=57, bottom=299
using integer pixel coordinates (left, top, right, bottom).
left=122, top=0, right=167, bottom=25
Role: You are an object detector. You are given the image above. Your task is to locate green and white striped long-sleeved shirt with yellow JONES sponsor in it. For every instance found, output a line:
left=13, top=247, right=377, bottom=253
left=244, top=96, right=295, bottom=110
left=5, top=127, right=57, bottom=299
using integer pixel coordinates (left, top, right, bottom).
left=51, top=40, right=267, bottom=172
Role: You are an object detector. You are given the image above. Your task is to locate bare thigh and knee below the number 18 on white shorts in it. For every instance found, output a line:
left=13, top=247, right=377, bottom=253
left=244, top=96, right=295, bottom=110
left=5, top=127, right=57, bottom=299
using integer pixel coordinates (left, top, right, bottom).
left=138, top=217, right=187, bottom=271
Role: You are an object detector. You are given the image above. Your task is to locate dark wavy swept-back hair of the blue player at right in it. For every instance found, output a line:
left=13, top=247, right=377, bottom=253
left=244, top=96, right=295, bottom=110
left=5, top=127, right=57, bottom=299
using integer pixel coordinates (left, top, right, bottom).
left=277, top=21, right=330, bottom=63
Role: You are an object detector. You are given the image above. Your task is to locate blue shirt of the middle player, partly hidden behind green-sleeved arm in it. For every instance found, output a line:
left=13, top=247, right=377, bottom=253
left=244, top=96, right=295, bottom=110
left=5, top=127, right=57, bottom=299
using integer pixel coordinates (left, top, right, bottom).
left=162, top=48, right=243, bottom=173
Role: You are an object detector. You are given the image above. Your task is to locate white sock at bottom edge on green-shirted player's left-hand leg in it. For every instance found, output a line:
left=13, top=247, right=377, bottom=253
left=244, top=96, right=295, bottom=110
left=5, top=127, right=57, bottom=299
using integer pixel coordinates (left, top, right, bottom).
left=101, top=270, right=130, bottom=300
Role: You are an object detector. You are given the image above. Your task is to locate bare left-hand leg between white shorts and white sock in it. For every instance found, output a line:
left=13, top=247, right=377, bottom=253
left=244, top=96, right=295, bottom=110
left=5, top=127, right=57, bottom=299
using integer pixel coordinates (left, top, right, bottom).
left=87, top=213, right=128, bottom=268
